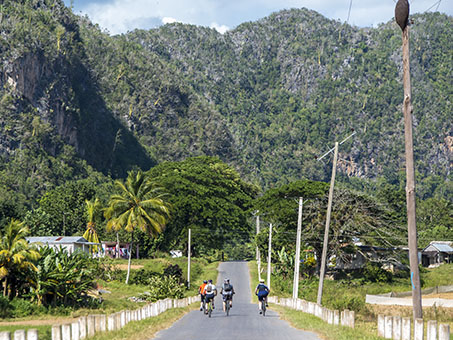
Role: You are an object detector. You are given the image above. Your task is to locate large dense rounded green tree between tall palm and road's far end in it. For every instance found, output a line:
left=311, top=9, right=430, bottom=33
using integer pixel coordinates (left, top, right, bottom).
left=145, top=156, right=258, bottom=255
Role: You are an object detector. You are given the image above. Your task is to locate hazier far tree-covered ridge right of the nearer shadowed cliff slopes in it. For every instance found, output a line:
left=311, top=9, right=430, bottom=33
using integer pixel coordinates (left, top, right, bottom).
left=128, top=9, right=453, bottom=191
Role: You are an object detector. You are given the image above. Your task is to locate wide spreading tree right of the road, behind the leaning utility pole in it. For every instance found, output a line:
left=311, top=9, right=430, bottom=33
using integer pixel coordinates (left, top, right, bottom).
left=255, top=181, right=405, bottom=274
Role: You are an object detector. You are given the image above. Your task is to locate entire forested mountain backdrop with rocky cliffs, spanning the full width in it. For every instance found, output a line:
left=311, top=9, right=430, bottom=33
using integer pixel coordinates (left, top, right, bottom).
left=0, top=0, right=453, bottom=210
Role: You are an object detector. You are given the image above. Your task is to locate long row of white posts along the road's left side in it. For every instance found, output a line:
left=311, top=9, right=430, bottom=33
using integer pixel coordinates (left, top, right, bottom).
left=0, top=296, right=198, bottom=340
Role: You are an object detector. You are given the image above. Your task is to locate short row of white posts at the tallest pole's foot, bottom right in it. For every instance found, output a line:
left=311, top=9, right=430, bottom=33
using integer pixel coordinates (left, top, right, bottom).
left=378, top=315, right=450, bottom=340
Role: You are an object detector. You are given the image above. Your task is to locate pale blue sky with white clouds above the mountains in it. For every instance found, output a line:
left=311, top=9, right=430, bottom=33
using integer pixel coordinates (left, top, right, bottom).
left=64, top=0, right=453, bottom=34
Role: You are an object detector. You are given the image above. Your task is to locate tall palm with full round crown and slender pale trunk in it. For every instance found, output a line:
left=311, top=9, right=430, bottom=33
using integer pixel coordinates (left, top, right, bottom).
left=104, top=170, right=169, bottom=284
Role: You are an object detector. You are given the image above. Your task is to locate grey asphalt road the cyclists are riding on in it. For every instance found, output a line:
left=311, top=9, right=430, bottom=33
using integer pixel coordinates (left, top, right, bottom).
left=155, top=262, right=320, bottom=340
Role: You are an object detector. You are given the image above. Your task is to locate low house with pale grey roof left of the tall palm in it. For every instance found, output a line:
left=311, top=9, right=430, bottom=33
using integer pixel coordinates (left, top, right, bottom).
left=25, top=236, right=99, bottom=254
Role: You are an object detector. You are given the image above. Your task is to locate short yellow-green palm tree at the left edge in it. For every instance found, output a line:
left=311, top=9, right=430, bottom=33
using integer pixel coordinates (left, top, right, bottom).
left=0, top=219, right=40, bottom=297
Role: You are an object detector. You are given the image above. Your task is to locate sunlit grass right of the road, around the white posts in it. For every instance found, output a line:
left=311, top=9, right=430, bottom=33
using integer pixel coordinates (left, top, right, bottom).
left=249, top=261, right=453, bottom=340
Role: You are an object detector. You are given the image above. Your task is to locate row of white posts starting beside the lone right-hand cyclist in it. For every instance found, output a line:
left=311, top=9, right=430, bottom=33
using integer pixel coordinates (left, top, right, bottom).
left=268, top=296, right=355, bottom=328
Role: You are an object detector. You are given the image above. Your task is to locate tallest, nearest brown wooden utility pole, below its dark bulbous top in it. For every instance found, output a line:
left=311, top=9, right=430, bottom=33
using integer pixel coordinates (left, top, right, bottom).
left=403, top=19, right=423, bottom=319
